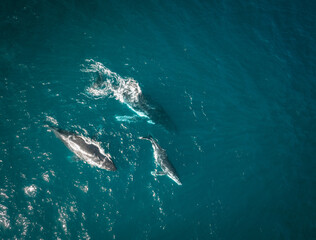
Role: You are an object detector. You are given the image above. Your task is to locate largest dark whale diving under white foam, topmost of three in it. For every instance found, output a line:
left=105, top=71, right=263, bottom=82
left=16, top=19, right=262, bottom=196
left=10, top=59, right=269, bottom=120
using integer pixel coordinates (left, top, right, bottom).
left=93, top=72, right=177, bottom=132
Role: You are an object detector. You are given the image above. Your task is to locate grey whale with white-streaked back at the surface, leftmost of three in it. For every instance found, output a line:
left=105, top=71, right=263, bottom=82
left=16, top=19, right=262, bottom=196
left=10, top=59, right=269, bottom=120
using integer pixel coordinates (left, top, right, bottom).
left=49, top=126, right=116, bottom=171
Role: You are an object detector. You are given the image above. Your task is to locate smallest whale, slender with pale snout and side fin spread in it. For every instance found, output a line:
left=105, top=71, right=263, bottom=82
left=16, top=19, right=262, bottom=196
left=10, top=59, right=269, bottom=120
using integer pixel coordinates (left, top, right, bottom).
left=139, top=136, right=182, bottom=185
